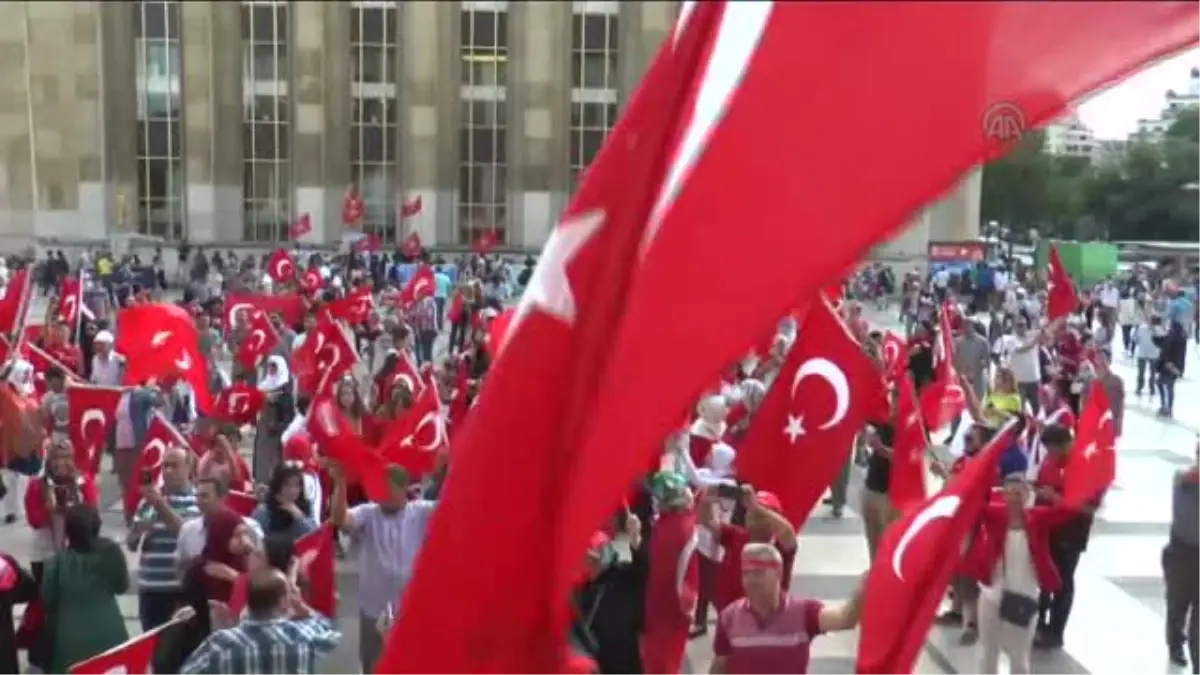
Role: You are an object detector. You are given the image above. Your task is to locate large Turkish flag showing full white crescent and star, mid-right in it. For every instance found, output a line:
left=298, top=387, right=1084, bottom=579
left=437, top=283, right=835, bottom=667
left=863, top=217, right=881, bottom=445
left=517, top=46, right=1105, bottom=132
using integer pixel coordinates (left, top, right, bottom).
left=737, top=294, right=883, bottom=528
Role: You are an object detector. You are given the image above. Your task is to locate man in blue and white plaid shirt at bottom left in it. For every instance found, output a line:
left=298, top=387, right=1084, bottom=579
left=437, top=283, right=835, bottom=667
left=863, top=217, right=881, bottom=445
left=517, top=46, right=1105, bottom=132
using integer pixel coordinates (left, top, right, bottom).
left=180, top=569, right=342, bottom=675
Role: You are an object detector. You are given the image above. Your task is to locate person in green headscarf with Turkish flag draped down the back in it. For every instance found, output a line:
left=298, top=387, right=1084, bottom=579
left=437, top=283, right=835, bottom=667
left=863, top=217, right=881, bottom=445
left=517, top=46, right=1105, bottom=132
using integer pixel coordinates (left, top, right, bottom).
left=642, top=471, right=700, bottom=675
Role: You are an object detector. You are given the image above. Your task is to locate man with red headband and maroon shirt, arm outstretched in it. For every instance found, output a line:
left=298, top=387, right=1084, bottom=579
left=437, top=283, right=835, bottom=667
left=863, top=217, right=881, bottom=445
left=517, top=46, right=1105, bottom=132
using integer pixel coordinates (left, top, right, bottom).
left=709, top=542, right=862, bottom=675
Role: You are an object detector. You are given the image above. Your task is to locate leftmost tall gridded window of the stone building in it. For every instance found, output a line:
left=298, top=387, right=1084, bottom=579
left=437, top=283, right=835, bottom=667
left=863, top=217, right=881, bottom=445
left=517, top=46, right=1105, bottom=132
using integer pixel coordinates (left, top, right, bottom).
left=135, top=0, right=186, bottom=240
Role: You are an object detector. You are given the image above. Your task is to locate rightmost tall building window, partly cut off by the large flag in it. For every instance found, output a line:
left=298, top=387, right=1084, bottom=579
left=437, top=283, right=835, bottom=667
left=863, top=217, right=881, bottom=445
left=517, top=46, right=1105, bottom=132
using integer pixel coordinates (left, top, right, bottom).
left=570, top=9, right=617, bottom=192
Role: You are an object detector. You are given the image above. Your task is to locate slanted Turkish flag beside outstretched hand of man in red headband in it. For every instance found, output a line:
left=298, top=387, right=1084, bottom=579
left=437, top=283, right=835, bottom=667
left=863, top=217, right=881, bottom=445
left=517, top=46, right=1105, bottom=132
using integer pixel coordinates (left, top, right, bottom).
left=857, top=420, right=1016, bottom=675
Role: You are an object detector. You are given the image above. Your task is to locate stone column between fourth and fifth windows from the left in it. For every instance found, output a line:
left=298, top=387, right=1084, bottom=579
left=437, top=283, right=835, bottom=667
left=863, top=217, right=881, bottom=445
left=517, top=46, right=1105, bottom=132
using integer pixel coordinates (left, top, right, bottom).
left=508, top=2, right=572, bottom=247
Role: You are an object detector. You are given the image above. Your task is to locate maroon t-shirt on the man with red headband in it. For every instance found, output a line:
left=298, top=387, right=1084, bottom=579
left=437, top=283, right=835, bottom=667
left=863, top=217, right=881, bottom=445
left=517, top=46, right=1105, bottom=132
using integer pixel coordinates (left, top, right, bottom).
left=713, top=595, right=821, bottom=675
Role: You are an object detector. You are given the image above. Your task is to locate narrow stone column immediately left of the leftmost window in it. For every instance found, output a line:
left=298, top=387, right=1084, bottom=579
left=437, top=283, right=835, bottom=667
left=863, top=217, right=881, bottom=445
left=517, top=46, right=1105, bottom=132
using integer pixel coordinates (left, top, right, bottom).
left=96, top=2, right=138, bottom=234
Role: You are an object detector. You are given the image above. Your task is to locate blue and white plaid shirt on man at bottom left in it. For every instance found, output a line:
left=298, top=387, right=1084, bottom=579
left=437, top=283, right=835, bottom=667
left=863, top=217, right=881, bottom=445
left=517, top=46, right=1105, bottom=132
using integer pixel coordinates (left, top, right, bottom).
left=179, top=616, right=342, bottom=675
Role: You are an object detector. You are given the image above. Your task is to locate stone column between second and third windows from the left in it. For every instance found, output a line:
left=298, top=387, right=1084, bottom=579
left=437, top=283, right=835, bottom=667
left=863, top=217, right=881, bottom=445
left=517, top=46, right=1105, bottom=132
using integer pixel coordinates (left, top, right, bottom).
left=290, top=0, right=350, bottom=241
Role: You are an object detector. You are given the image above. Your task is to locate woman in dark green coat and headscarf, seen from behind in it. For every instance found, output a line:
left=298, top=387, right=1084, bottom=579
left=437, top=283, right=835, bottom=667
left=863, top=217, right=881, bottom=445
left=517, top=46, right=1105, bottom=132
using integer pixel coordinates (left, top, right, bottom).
left=42, top=504, right=130, bottom=675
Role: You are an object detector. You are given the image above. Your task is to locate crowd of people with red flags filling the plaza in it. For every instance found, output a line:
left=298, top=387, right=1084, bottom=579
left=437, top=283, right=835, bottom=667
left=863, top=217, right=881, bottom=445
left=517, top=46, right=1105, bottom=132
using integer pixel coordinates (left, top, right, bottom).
left=0, top=239, right=1200, bottom=675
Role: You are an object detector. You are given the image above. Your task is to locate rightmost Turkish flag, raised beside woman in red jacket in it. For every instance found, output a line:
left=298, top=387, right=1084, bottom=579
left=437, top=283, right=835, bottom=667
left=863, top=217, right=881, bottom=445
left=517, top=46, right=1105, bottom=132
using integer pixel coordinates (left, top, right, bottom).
left=1062, top=380, right=1117, bottom=508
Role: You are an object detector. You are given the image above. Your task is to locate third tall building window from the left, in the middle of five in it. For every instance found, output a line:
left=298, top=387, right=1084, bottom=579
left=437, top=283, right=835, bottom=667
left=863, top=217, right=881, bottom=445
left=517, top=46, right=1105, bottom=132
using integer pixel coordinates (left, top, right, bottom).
left=350, top=1, right=400, bottom=243
